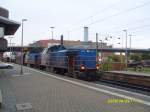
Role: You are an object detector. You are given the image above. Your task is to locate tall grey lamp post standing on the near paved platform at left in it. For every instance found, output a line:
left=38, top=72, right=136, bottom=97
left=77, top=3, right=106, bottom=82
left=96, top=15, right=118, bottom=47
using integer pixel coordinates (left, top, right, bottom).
left=20, top=19, right=27, bottom=75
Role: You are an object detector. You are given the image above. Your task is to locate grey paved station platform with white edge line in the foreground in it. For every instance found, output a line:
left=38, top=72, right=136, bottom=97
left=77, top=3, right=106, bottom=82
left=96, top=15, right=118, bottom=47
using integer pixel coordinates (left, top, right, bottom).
left=0, top=65, right=150, bottom=112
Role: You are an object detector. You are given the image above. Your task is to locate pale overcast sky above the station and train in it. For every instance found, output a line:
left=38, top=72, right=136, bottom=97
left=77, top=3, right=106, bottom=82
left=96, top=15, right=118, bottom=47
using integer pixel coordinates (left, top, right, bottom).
left=0, top=0, right=150, bottom=48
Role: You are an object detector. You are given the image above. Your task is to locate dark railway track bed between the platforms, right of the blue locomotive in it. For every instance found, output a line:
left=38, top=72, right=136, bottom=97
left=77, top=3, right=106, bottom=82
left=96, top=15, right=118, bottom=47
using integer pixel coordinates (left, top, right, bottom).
left=99, top=71, right=150, bottom=92
